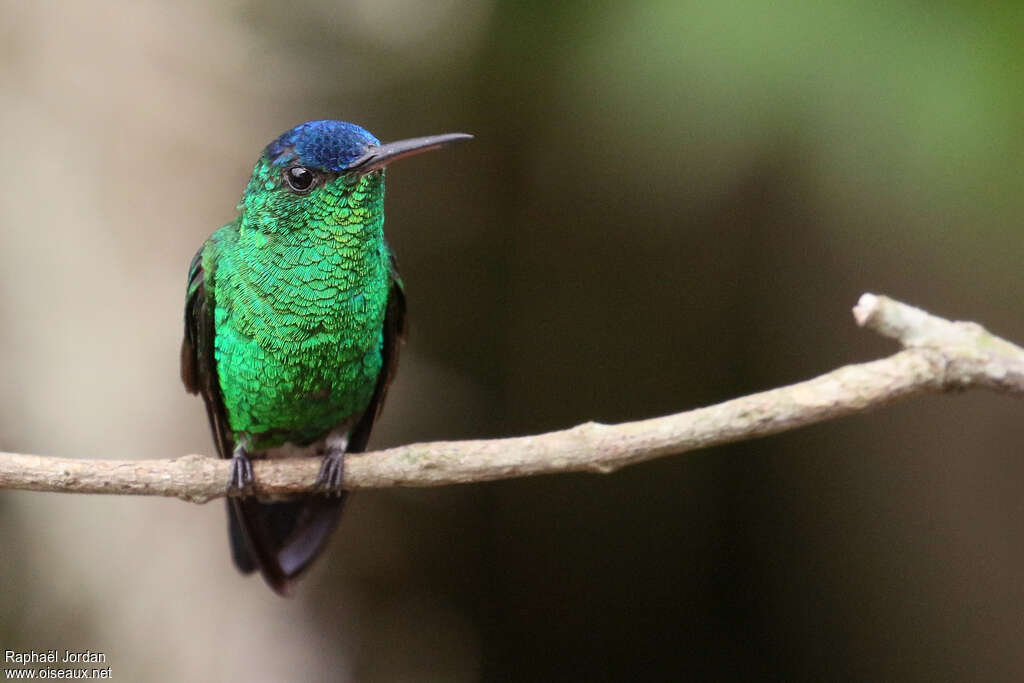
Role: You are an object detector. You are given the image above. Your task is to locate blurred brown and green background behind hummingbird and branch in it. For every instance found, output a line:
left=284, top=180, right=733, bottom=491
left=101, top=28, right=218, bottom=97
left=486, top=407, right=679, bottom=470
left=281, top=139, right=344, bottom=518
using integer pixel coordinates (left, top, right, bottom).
left=0, top=0, right=1024, bottom=681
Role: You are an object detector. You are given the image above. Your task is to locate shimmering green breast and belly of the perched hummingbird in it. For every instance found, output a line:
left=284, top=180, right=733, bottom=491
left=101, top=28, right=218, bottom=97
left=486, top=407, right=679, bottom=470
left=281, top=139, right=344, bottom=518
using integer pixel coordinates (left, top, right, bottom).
left=214, top=216, right=391, bottom=451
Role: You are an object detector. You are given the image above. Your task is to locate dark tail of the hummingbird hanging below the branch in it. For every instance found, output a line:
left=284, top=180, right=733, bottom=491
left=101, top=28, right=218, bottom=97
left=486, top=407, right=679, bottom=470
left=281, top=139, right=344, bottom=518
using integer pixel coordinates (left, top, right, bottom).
left=228, top=493, right=345, bottom=595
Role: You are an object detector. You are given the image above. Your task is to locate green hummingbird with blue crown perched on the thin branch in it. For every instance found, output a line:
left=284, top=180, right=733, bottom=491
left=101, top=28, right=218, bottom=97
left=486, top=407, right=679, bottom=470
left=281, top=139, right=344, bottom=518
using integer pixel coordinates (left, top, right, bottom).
left=181, top=121, right=472, bottom=595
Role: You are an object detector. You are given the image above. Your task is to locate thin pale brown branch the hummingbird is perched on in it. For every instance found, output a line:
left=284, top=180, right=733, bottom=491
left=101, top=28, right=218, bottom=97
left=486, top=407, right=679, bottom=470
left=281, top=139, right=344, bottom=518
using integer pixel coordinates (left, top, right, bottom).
left=0, top=294, right=1024, bottom=503
